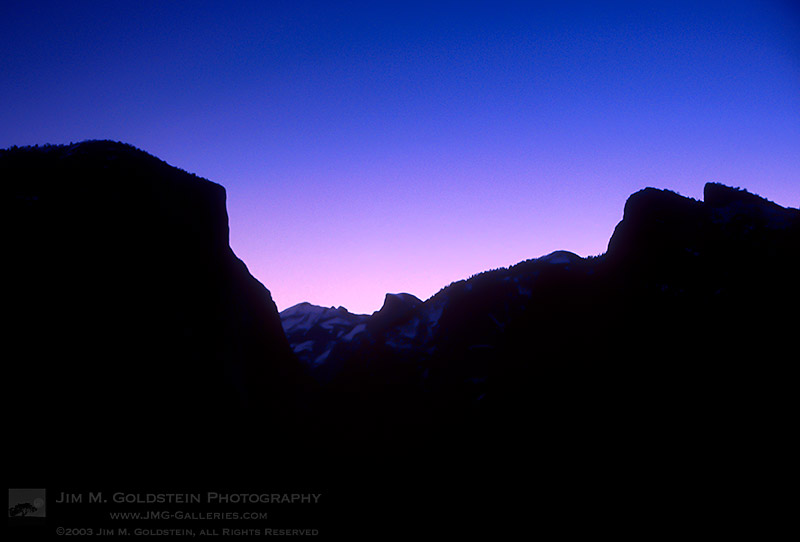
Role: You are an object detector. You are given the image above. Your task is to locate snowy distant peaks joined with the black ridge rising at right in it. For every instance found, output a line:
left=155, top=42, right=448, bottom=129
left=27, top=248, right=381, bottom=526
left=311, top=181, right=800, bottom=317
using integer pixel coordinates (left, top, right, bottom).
left=281, top=183, right=800, bottom=442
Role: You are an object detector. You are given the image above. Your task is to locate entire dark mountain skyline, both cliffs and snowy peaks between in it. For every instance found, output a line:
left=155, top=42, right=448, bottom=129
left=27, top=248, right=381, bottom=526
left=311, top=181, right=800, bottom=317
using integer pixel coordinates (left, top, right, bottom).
left=7, top=141, right=800, bottom=532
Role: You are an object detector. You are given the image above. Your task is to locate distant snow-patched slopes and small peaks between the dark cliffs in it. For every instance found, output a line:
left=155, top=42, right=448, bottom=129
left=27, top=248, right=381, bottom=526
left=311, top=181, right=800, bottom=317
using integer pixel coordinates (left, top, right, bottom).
left=280, top=251, right=589, bottom=392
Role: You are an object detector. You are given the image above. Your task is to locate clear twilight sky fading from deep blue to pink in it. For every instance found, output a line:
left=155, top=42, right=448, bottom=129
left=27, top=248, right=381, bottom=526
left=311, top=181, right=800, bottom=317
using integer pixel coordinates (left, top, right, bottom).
left=0, top=0, right=800, bottom=314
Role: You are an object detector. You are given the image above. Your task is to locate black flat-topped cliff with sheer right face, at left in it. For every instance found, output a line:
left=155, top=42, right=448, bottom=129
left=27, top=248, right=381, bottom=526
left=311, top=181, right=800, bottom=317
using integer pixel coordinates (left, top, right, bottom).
left=5, top=141, right=316, bottom=484
